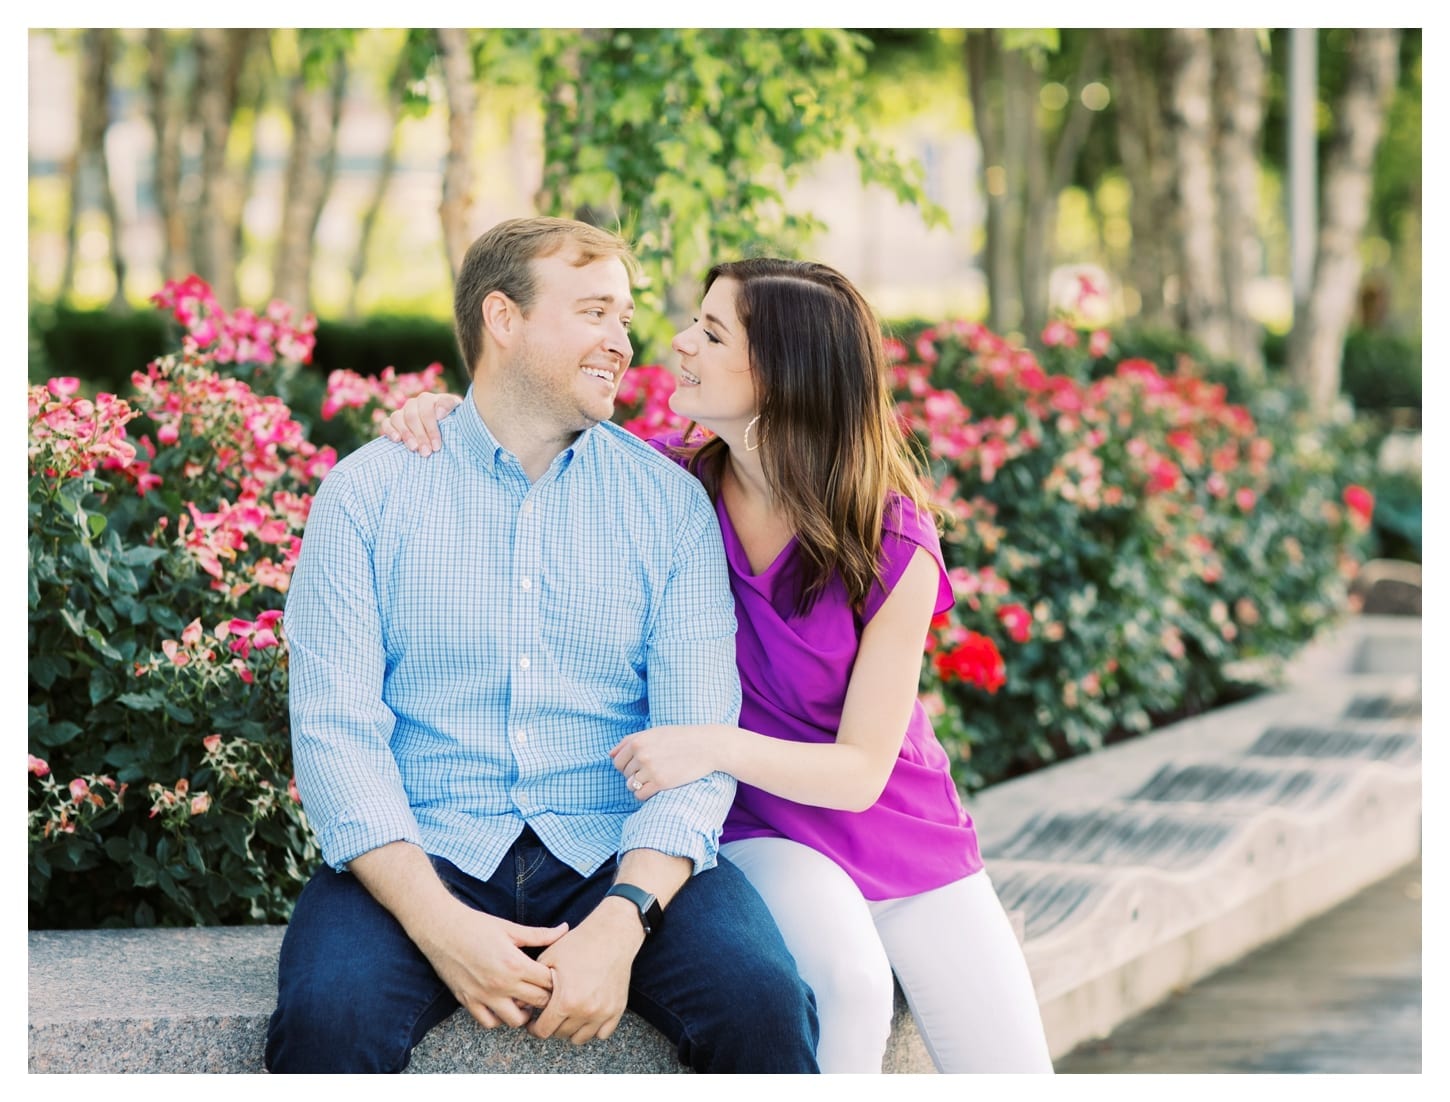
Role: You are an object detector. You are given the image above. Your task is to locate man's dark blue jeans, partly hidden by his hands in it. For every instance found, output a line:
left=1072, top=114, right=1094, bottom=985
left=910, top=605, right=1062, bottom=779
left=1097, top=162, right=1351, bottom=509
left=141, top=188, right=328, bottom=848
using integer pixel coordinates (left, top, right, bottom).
left=267, top=829, right=819, bottom=1073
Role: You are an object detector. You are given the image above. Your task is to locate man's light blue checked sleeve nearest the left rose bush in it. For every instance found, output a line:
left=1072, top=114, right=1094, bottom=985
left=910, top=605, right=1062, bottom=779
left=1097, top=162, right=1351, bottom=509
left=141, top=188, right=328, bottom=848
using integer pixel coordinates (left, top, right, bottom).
left=283, top=468, right=422, bottom=870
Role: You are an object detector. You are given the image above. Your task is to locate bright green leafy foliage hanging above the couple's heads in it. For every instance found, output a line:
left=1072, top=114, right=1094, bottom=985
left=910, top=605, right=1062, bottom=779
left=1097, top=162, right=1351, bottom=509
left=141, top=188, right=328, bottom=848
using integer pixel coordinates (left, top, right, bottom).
left=534, top=29, right=945, bottom=352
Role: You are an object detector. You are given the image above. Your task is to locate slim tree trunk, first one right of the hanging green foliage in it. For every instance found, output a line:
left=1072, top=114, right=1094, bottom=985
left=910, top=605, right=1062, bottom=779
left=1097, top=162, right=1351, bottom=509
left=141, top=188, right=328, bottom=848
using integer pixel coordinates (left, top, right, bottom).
left=966, top=30, right=1021, bottom=334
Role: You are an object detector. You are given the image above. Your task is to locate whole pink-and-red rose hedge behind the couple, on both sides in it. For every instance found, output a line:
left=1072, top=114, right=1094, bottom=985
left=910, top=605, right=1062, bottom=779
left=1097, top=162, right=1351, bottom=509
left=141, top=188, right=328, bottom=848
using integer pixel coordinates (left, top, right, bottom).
left=28, top=280, right=1373, bottom=927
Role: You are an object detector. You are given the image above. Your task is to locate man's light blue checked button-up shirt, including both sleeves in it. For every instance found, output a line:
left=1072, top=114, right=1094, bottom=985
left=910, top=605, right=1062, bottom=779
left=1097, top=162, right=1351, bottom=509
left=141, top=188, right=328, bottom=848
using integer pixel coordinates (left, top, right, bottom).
left=283, top=389, right=740, bottom=879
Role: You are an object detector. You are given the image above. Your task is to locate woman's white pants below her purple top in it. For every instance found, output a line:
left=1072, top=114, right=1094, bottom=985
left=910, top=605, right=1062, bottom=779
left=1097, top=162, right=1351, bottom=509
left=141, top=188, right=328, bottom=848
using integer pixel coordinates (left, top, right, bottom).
left=721, top=838, right=1053, bottom=1073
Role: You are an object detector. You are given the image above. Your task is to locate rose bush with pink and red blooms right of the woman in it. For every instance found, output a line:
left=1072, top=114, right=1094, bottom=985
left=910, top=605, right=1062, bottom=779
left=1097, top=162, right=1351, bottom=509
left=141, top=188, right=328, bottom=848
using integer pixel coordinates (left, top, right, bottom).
left=890, top=323, right=1369, bottom=789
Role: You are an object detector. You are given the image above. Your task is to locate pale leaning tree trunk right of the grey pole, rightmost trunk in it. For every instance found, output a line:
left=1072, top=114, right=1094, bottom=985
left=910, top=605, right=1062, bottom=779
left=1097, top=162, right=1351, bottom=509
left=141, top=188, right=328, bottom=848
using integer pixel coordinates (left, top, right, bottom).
left=1289, top=29, right=1399, bottom=418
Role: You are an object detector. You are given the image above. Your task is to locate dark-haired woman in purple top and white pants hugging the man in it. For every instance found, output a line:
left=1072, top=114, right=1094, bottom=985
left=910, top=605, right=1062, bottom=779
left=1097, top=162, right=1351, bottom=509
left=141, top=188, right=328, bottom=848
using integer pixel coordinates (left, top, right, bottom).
left=384, top=258, right=1051, bottom=1072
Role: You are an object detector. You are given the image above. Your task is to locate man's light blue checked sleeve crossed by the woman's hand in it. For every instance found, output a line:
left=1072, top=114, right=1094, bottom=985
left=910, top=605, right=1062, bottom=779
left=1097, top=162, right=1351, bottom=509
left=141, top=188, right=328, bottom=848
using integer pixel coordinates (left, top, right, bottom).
left=619, top=490, right=741, bottom=873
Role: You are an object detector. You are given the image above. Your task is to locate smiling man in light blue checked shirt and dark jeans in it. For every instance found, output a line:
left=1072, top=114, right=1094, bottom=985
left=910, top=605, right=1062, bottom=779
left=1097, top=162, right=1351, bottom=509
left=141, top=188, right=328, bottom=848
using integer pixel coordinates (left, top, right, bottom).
left=267, top=219, right=816, bottom=1072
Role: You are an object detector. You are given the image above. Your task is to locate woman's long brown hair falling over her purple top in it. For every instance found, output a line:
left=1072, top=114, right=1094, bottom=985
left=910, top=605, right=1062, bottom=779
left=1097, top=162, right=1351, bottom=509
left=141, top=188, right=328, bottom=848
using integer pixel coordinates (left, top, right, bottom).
left=669, top=258, right=937, bottom=613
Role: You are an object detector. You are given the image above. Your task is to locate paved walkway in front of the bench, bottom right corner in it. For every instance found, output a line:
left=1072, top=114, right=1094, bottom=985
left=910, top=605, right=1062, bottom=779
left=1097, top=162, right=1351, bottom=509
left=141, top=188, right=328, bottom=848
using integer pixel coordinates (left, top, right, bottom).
left=1056, top=860, right=1421, bottom=1078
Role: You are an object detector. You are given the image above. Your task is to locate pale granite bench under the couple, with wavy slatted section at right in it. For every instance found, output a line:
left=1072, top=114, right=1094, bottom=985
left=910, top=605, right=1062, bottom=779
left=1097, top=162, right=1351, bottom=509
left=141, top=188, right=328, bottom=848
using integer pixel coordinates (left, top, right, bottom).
left=29, top=616, right=1421, bottom=1073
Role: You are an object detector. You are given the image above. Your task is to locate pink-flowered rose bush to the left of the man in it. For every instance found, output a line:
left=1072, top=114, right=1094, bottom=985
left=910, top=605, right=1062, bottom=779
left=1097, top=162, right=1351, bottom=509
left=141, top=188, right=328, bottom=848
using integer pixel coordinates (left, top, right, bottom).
left=28, top=278, right=420, bottom=927
